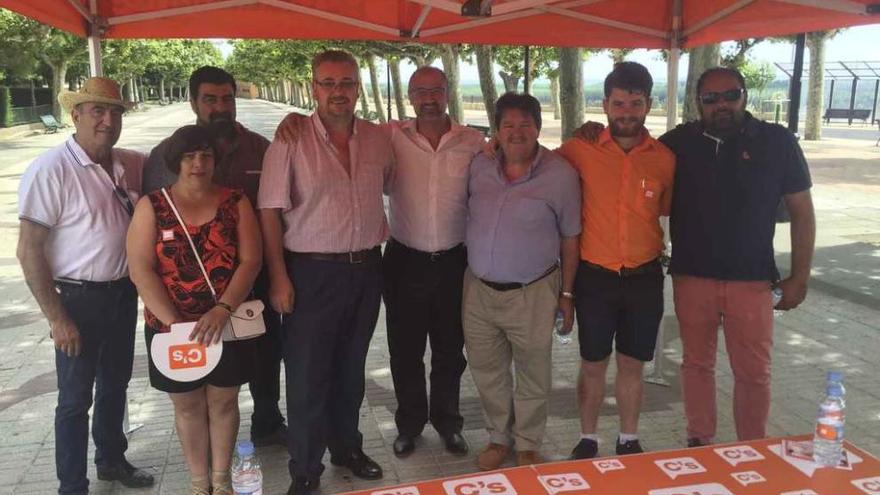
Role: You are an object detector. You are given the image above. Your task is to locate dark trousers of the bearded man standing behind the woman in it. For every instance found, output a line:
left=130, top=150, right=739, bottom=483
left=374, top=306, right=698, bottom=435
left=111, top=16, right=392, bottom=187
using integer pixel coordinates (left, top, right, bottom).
left=249, top=269, right=284, bottom=438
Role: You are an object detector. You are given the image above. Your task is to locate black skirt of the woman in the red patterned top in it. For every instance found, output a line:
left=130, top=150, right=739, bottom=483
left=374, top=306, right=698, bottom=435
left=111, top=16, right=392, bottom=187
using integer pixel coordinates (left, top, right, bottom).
left=144, top=325, right=257, bottom=394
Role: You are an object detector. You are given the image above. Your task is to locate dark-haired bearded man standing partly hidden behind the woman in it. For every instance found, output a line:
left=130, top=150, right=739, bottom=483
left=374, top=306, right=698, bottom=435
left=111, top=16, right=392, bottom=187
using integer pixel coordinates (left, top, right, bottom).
left=143, top=66, right=287, bottom=447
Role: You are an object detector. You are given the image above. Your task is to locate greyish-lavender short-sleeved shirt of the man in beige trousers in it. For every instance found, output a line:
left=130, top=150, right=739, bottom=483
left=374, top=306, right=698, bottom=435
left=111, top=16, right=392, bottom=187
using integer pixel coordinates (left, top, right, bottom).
left=467, top=146, right=581, bottom=283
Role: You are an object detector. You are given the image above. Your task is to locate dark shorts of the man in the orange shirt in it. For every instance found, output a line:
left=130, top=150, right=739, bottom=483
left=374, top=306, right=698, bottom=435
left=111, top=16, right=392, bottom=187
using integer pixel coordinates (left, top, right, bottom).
left=575, top=261, right=663, bottom=362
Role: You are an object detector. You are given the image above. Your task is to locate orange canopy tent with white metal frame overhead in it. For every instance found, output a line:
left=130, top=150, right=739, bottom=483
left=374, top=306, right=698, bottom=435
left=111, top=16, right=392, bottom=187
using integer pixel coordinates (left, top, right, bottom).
left=0, top=0, right=880, bottom=125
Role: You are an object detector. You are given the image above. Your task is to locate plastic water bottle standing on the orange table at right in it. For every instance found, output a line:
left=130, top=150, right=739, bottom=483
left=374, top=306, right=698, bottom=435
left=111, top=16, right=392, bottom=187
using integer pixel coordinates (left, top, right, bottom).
left=813, top=371, right=846, bottom=466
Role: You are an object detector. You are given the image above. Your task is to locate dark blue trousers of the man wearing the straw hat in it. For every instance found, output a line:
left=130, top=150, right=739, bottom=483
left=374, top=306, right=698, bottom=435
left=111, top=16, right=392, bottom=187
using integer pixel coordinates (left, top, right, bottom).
left=55, top=279, right=137, bottom=494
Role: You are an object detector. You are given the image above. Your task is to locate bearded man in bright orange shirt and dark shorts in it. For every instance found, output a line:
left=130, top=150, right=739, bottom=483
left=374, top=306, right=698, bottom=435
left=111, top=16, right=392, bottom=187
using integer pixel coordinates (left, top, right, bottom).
left=558, top=62, right=675, bottom=459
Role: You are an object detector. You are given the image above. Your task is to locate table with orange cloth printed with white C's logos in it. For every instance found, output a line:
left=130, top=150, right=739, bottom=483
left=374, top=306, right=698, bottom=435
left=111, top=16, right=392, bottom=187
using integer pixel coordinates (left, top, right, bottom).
left=350, top=436, right=880, bottom=495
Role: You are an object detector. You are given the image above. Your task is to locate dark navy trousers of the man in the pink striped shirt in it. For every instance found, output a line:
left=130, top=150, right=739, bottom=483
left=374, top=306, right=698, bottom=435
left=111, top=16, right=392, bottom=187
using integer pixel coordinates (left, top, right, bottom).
left=282, top=252, right=382, bottom=478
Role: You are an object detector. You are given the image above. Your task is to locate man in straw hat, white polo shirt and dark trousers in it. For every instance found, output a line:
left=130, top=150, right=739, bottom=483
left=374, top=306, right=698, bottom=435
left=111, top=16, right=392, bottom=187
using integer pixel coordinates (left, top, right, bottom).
left=17, top=77, right=153, bottom=494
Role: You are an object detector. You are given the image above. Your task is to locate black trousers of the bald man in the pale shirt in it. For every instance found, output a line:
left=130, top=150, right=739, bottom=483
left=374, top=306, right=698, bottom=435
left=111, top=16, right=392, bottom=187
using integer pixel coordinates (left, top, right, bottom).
left=382, top=240, right=467, bottom=436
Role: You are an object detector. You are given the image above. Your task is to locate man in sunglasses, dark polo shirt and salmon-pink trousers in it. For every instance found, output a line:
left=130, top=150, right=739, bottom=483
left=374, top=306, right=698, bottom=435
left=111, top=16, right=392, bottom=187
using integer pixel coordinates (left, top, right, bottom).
left=660, top=68, right=816, bottom=446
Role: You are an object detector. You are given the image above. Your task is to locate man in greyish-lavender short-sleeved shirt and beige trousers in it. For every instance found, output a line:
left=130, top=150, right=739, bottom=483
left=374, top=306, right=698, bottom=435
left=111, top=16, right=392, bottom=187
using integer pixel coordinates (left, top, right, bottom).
left=462, top=93, right=581, bottom=471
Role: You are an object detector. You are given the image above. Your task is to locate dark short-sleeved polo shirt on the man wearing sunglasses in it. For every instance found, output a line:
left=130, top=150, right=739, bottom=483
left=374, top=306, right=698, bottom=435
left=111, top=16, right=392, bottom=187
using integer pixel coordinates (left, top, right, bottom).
left=660, top=113, right=812, bottom=281
